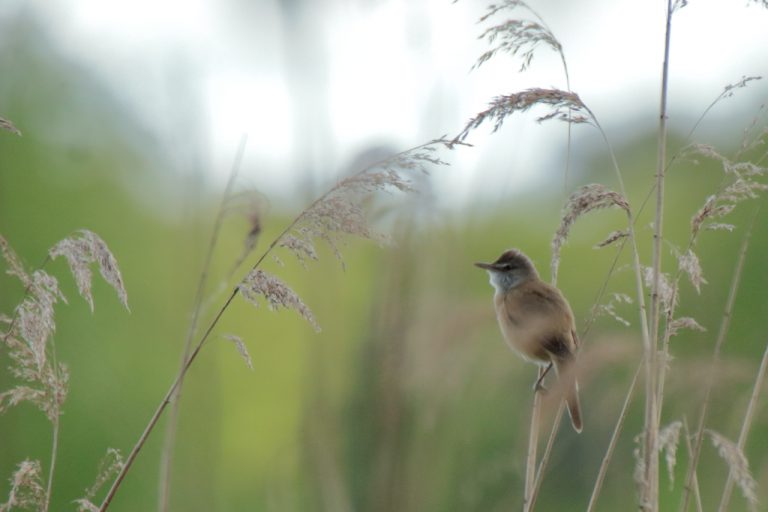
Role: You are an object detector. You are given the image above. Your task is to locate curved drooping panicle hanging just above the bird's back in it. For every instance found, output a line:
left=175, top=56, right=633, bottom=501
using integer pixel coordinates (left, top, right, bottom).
left=550, top=183, right=630, bottom=280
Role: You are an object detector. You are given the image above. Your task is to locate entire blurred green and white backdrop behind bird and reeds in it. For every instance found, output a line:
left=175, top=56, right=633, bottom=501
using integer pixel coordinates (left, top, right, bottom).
left=0, top=0, right=768, bottom=511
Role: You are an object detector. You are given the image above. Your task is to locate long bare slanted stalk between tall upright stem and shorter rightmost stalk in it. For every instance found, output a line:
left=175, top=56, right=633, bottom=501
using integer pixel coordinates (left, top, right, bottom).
left=680, top=212, right=757, bottom=512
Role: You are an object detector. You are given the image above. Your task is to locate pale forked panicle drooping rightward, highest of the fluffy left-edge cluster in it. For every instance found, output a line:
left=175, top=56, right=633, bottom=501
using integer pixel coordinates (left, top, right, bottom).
left=49, top=229, right=129, bottom=311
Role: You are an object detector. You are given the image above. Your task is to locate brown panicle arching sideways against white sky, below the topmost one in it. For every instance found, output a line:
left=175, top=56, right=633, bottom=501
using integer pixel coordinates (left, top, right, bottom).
left=454, top=88, right=592, bottom=142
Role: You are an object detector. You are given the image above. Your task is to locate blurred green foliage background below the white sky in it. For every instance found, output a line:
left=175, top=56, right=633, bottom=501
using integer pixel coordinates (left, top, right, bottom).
left=0, top=1, right=768, bottom=511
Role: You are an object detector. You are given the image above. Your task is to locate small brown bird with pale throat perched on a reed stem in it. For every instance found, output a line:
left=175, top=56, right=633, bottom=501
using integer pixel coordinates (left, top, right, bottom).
left=475, top=249, right=582, bottom=432
